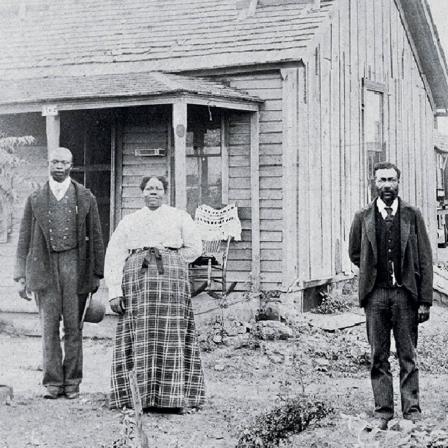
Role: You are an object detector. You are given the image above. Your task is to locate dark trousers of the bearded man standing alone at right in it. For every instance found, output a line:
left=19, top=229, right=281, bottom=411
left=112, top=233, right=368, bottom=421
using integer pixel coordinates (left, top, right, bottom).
left=365, top=288, right=421, bottom=420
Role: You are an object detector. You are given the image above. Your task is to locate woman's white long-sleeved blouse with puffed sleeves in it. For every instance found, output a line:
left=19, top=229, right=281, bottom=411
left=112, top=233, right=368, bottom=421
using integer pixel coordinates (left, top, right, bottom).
left=104, top=205, right=202, bottom=299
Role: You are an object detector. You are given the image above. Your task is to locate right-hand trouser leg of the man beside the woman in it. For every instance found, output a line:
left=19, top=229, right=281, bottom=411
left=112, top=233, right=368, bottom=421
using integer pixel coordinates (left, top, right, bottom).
left=59, top=249, right=82, bottom=392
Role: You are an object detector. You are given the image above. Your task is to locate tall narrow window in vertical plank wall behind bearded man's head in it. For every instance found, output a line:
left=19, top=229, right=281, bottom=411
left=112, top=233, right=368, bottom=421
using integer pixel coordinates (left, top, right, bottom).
left=363, top=85, right=386, bottom=201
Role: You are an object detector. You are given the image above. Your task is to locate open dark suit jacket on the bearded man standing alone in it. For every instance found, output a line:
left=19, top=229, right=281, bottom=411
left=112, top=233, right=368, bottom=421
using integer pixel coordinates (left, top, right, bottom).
left=349, top=199, right=433, bottom=307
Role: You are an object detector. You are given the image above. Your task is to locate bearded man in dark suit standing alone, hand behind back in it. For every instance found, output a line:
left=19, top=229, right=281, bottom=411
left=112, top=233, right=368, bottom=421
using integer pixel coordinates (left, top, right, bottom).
left=349, top=162, right=433, bottom=429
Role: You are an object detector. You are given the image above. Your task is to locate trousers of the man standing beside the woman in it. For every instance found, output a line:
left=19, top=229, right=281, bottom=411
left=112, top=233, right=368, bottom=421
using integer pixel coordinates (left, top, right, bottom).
left=38, top=248, right=82, bottom=392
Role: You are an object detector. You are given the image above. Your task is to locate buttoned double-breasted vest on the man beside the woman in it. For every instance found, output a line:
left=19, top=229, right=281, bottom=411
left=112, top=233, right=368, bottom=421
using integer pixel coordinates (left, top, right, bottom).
left=48, top=183, right=78, bottom=252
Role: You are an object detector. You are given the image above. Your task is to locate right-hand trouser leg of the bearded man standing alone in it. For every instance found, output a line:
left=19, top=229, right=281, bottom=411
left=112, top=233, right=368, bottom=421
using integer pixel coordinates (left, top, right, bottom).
left=392, top=288, right=421, bottom=417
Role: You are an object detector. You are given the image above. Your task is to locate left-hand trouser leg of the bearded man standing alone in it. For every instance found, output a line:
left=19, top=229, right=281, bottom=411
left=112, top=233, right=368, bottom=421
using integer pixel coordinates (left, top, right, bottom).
left=366, top=288, right=394, bottom=420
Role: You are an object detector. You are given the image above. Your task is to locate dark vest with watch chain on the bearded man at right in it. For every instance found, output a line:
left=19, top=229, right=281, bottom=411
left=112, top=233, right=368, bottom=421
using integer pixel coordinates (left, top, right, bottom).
left=375, top=206, right=401, bottom=288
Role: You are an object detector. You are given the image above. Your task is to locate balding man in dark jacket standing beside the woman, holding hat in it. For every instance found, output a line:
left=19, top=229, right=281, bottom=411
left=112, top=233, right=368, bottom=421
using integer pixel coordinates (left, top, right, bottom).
left=14, top=148, right=104, bottom=399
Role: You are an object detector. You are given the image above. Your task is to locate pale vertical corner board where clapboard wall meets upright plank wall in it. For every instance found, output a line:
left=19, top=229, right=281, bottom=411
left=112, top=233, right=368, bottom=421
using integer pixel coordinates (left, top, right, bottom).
left=281, top=68, right=298, bottom=288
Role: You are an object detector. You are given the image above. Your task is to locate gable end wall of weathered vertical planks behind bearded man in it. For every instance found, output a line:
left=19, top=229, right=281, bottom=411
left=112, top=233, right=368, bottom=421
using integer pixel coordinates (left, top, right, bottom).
left=297, top=0, right=436, bottom=280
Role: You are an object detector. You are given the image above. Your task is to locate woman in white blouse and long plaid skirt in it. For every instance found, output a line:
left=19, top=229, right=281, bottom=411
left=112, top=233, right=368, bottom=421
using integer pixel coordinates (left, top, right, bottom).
left=105, top=176, right=205, bottom=410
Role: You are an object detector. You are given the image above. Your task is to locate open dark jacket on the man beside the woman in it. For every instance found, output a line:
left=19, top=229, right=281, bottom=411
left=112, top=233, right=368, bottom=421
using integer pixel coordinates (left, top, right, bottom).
left=14, top=180, right=104, bottom=294
